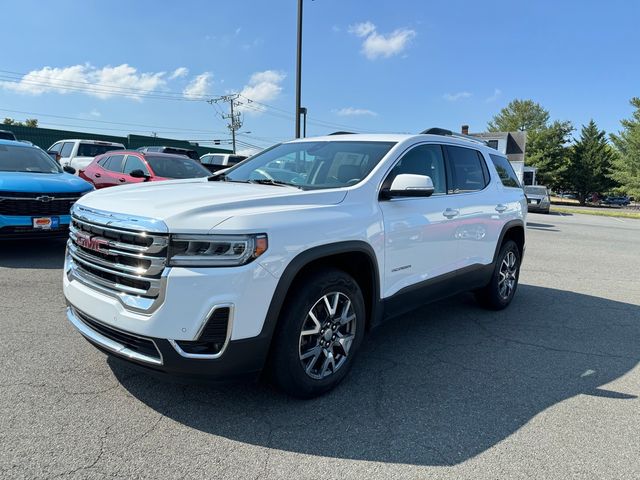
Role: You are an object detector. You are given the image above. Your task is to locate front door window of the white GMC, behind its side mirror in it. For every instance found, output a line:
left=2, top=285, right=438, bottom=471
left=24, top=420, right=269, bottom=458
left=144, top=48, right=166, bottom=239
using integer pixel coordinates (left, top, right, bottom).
left=383, top=144, right=447, bottom=195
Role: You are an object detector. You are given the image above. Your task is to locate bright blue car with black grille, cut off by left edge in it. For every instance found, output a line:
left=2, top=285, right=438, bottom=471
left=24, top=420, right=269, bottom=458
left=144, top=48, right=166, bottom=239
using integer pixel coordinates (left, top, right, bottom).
left=0, top=140, right=93, bottom=240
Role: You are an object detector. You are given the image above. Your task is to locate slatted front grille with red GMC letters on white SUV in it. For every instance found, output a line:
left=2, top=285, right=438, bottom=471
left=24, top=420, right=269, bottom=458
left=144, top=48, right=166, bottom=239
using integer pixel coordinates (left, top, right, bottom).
left=67, top=216, right=168, bottom=298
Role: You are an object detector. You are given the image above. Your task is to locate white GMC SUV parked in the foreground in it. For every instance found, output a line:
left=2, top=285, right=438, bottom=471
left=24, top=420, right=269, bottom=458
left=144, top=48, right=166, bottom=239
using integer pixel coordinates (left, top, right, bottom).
left=64, top=129, right=527, bottom=397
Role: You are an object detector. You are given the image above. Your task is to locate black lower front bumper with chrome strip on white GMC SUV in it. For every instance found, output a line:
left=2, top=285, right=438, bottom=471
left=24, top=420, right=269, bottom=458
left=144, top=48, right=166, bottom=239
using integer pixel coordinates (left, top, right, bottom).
left=67, top=306, right=270, bottom=381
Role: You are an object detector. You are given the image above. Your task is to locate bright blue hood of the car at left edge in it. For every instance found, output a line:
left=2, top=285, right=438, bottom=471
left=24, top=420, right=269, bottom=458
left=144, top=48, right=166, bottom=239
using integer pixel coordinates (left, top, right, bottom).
left=0, top=172, right=93, bottom=193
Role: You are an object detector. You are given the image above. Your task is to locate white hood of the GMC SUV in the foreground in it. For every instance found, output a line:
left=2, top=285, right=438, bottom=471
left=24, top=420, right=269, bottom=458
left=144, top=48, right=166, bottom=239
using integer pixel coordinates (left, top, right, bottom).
left=76, top=177, right=346, bottom=233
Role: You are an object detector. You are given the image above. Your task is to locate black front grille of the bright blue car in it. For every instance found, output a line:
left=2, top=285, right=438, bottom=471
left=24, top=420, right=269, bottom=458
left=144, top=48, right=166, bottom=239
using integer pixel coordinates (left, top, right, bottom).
left=0, top=192, right=80, bottom=217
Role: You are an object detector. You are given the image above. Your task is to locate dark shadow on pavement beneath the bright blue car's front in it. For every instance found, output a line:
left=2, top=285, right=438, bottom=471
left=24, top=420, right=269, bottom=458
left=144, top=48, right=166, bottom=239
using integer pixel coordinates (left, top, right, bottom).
left=0, top=238, right=66, bottom=269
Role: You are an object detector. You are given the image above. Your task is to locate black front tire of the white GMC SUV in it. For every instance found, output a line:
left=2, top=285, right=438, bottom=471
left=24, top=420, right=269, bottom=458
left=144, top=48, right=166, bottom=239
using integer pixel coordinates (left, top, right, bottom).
left=270, top=269, right=366, bottom=398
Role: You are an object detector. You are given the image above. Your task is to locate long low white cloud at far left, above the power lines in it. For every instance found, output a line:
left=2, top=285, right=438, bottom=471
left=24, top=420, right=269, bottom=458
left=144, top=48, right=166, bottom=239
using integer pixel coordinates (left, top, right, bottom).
left=0, top=63, right=166, bottom=100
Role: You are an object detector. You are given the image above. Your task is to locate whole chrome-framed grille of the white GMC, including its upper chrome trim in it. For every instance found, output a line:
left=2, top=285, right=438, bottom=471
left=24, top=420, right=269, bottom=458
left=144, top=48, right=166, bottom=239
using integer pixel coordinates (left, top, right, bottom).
left=66, top=204, right=169, bottom=314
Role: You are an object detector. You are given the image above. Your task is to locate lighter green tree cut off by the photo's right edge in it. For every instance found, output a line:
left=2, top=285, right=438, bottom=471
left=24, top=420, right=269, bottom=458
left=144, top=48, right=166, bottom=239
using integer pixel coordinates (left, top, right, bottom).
left=611, top=97, right=640, bottom=200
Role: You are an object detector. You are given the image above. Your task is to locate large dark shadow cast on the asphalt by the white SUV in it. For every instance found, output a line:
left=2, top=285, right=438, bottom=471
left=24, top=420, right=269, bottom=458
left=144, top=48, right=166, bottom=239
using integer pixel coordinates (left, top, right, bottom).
left=109, top=285, right=640, bottom=465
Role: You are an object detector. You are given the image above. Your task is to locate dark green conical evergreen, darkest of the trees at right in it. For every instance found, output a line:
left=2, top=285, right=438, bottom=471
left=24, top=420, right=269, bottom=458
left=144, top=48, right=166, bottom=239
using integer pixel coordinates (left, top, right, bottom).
left=565, top=120, right=615, bottom=205
